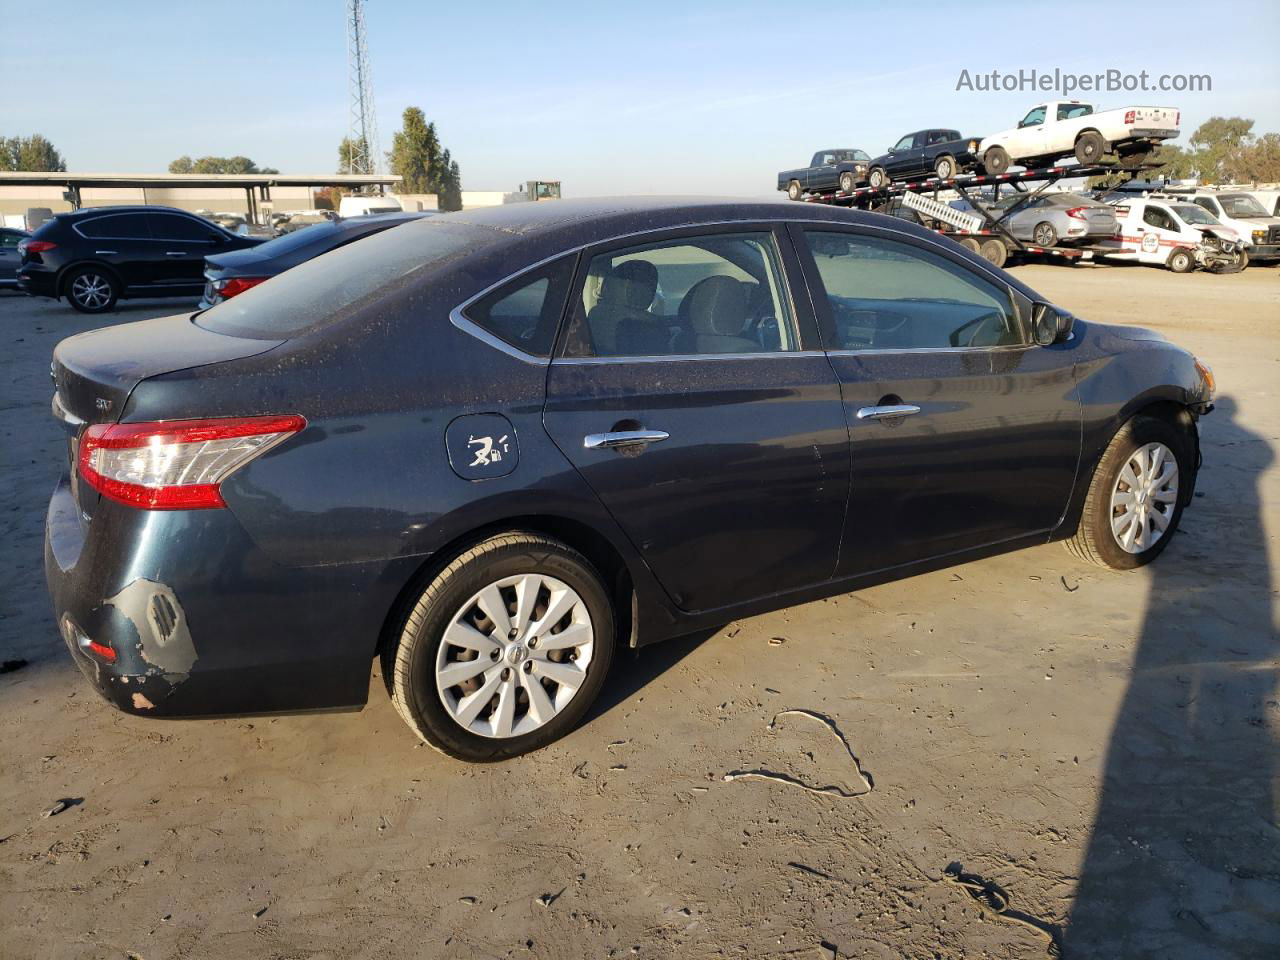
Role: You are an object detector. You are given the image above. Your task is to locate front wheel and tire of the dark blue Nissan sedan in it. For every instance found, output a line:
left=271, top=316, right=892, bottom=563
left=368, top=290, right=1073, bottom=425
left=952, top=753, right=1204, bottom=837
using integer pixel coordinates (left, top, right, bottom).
left=1065, top=415, right=1196, bottom=570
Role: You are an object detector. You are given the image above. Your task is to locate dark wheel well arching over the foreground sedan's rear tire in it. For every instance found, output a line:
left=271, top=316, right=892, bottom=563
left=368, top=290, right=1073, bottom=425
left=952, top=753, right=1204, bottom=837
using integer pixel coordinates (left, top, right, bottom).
left=374, top=515, right=635, bottom=657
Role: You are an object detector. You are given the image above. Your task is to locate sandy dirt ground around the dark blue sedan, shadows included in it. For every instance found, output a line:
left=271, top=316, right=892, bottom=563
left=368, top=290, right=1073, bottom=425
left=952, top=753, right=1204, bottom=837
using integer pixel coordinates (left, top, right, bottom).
left=0, top=265, right=1280, bottom=960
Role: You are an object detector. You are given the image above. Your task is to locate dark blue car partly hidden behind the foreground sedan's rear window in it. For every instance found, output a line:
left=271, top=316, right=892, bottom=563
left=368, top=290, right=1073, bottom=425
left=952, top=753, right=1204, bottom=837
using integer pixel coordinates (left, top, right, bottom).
left=200, top=214, right=430, bottom=310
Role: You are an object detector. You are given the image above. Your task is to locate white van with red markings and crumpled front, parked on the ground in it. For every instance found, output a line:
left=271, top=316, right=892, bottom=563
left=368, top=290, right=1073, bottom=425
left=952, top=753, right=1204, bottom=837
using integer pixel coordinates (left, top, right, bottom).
left=1102, top=195, right=1249, bottom=274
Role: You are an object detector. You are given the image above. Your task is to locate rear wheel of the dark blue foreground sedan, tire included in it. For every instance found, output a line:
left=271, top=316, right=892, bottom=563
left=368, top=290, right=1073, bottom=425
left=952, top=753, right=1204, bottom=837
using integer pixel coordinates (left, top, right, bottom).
left=383, top=532, right=616, bottom=762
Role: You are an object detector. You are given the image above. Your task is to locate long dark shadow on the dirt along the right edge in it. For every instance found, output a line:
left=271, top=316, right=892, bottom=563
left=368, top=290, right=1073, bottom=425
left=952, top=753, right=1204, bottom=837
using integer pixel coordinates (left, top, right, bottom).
left=1062, top=397, right=1280, bottom=960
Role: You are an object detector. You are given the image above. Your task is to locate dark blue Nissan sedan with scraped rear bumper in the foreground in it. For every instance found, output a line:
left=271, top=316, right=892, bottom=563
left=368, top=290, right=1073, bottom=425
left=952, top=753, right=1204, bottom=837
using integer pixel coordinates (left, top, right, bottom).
left=45, top=198, right=1213, bottom=760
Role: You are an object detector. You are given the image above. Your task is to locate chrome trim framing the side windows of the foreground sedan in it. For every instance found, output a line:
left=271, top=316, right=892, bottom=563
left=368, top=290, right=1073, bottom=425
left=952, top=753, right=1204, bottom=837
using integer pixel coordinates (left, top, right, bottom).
left=445, top=207, right=1036, bottom=366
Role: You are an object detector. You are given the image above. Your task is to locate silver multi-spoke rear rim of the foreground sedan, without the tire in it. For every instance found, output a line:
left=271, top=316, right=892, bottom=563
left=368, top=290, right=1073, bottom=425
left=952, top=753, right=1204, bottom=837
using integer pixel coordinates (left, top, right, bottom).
left=435, top=573, right=595, bottom=739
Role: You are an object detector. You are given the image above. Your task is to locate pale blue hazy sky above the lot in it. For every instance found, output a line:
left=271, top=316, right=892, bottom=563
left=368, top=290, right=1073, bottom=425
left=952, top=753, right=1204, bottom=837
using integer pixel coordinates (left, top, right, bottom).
left=0, top=0, right=1280, bottom=196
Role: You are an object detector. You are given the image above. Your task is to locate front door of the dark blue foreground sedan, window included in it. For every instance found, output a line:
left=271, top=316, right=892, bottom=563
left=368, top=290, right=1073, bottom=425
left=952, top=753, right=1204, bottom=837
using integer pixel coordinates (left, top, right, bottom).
left=792, top=224, right=1080, bottom=575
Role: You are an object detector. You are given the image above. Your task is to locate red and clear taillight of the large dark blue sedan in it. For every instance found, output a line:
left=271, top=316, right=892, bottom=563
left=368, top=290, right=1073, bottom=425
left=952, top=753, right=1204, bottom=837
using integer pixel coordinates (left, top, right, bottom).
left=79, top=415, right=307, bottom=509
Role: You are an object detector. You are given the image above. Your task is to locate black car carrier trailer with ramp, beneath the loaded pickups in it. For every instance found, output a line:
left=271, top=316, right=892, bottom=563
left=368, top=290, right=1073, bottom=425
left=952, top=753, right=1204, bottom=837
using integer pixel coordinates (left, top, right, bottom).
left=804, top=164, right=1160, bottom=266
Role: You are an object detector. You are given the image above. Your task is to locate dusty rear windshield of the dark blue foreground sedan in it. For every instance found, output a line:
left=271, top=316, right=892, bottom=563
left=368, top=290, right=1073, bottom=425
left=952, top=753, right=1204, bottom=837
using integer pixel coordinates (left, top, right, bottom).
left=196, top=218, right=502, bottom=340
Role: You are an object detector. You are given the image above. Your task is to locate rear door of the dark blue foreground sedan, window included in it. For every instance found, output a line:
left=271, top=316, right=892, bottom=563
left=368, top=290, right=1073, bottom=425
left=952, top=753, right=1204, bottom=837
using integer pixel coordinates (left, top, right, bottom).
left=544, top=224, right=849, bottom=611
